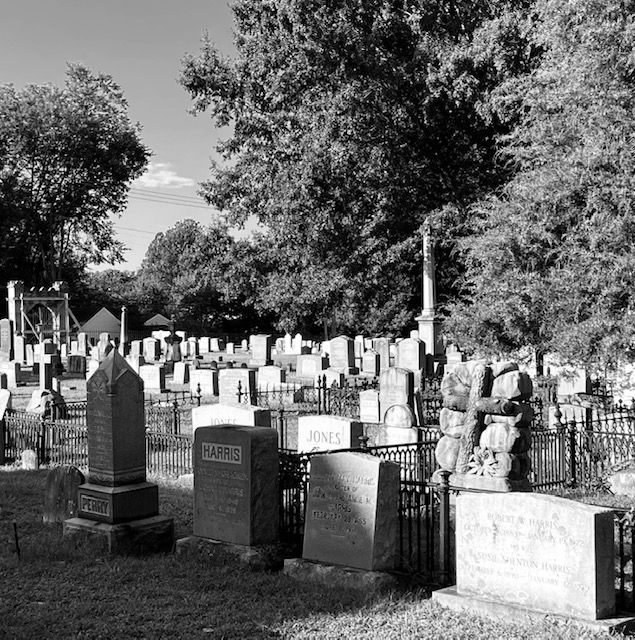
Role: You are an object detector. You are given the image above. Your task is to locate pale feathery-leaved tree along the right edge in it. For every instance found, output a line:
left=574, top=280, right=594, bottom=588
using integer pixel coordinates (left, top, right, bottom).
left=448, top=0, right=635, bottom=367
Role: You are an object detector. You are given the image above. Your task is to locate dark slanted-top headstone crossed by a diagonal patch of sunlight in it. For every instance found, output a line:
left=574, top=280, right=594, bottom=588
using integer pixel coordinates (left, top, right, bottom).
left=302, top=452, right=399, bottom=571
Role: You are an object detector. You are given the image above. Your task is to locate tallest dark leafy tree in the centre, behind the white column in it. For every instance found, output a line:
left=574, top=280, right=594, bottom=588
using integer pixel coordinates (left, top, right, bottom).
left=181, top=0, right=531, bottom=332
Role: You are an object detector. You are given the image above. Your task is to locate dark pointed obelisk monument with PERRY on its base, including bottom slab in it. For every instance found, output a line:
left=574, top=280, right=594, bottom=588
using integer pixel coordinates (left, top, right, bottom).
left=64, top=350, right=174, bottom=552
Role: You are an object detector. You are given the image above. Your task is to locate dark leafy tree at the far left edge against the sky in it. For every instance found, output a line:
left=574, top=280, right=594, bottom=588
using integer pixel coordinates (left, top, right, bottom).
left=0, top=65, right=149, bottom=284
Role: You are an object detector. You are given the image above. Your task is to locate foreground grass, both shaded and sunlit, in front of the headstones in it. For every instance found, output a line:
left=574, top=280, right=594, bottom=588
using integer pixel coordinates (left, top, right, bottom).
left=0, top=467, right=622, bottom=640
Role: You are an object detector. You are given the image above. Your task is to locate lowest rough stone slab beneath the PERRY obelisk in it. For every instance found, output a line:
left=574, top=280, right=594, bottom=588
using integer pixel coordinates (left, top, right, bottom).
left=63, top=516, right=174, bottom=555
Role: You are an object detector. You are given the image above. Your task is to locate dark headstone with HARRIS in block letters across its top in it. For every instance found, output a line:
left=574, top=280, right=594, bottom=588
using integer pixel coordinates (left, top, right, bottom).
left=193, top=425, right=279, bottom=546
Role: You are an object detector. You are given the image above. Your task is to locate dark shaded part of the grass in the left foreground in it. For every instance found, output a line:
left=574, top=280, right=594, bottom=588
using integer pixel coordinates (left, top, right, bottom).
left=0, top=470, right=428, bottom=638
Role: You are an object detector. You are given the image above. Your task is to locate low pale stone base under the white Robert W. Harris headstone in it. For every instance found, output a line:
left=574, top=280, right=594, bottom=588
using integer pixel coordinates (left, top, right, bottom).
left=432, top=586, right=635, bottom=632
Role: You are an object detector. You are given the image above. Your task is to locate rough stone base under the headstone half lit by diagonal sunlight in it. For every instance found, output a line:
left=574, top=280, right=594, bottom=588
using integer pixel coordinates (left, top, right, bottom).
left=282, top=558, right=397, bottom=593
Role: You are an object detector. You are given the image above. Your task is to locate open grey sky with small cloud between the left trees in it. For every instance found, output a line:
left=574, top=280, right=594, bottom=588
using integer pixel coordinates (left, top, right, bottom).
left=0, top=0, right=238, bottom=269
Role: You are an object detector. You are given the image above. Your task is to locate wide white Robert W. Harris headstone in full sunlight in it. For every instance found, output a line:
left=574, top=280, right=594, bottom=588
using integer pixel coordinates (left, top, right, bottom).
left=433, top=493, right=615, bottom=620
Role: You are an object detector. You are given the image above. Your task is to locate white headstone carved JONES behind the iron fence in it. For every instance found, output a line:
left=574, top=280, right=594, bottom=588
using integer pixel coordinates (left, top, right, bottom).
left=298, top=415, right=364, bottom=451
